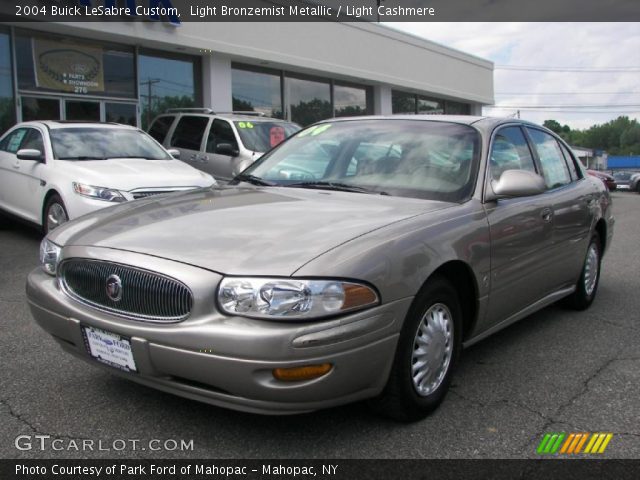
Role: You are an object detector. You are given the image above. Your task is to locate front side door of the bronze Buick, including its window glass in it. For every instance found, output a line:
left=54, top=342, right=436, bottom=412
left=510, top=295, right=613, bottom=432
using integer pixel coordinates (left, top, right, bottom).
left=485, top=125, right=553, bottom=323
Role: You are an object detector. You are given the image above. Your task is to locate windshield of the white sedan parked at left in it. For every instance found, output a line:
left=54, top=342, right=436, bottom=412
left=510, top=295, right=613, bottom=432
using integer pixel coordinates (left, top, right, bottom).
left=51, top=127, right=171, bottom=160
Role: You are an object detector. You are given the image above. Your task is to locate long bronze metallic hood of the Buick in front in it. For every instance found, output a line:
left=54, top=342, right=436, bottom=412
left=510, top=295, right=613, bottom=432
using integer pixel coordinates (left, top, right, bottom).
left=50, top=187, right=452, bottom=276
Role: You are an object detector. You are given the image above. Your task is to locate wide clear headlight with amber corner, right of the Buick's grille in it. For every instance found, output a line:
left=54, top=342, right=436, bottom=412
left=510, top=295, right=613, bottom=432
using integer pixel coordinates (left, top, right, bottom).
left=218, top=277, right=379, bottom=320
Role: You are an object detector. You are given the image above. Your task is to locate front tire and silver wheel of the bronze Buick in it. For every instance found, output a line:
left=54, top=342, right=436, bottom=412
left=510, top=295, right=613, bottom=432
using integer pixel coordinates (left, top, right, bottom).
left=371, top=277, right=462, bottom=422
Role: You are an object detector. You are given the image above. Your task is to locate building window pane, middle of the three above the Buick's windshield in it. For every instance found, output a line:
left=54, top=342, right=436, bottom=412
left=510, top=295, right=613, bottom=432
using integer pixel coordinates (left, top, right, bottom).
left=285, top=77, right=333, bottom=127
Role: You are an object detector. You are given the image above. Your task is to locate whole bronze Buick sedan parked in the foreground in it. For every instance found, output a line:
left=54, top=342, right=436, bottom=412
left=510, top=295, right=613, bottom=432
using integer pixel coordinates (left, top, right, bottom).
left=27, top=116, right=613, bottom=420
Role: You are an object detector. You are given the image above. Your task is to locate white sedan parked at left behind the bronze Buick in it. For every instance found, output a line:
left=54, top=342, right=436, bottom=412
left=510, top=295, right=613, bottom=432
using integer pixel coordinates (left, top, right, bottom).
left=0, top=121, right=215, bottom=233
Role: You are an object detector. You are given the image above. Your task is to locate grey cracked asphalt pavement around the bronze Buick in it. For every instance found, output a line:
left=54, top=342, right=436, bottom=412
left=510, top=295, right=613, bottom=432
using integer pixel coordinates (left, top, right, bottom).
left=0, top=193, right=640, bottom=458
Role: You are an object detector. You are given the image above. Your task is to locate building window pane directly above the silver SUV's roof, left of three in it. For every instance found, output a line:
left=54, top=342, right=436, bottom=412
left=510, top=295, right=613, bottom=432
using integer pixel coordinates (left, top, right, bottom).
left=231, top=65, right=283, bottom=118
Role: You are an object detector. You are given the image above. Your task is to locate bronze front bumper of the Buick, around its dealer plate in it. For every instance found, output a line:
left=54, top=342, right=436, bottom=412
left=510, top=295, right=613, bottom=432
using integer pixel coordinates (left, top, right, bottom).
left=27, top=252, right=412, bottom=414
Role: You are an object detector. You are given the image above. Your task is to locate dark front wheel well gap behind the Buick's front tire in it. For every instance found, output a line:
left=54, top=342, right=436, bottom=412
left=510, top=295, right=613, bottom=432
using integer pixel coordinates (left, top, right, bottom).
left=432, top=260, right=478, bottom=340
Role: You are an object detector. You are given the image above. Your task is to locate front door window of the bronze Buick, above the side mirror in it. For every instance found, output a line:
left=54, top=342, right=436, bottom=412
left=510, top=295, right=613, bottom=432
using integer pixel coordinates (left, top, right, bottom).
left=489, top=127, right=536, bottom=180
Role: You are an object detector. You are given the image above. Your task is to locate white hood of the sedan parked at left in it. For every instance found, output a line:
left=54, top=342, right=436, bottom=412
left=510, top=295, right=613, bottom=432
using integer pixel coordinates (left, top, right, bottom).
left=56, top=158, right=214, bottom=191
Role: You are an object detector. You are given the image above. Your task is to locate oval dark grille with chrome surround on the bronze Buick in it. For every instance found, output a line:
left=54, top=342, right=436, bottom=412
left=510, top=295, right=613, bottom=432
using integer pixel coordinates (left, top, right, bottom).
left=60, top=259, right=193, bottom=322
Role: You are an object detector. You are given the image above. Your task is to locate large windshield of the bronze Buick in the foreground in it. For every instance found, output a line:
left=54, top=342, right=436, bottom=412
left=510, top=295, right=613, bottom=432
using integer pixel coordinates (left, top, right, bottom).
left=239, top=119, right=480, bottom=202
